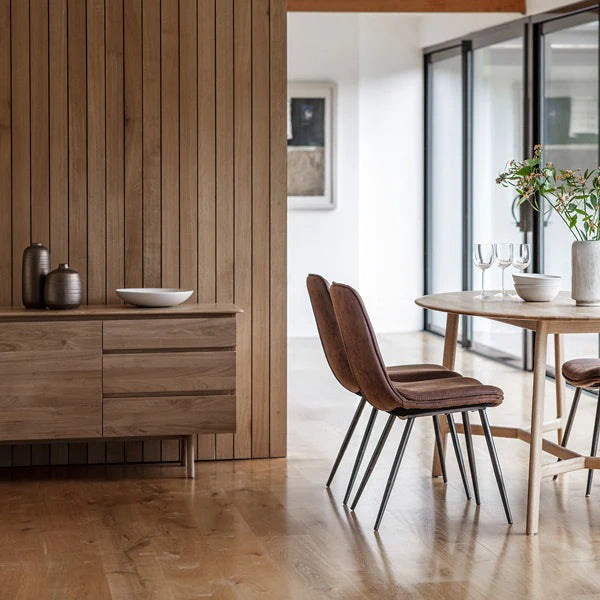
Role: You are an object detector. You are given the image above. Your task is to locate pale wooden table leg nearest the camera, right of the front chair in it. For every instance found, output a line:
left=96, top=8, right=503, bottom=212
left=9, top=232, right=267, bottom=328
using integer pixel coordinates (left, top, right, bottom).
left=526, top=321, right=548, bottom=535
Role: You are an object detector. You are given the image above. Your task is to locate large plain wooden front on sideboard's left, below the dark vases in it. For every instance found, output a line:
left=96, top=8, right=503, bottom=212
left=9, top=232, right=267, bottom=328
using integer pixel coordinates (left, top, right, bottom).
left=0, top=322, right=102, bottom=441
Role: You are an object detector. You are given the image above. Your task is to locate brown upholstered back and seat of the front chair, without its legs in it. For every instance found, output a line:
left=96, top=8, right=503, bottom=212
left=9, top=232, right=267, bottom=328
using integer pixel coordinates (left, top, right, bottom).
left=330, top=283, right=503, bottom=412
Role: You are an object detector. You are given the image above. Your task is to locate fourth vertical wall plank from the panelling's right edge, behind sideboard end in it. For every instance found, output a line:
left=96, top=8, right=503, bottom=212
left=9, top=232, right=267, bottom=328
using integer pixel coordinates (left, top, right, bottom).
left=215, top=0, right=235, bottom=459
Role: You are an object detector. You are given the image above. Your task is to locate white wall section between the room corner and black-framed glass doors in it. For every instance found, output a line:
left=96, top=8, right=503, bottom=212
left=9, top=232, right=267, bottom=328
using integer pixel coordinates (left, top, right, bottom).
left=359, top=14, right=423, bottom=331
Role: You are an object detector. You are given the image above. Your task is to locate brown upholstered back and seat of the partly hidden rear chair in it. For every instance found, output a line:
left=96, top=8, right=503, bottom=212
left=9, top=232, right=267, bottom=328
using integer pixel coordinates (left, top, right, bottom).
left=306, top=274, right=459, bottom=393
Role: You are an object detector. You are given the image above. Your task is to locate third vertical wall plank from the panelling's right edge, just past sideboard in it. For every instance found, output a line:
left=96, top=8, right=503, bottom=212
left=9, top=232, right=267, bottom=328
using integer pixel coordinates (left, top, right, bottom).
left=233, top=0, right=252, bottom=458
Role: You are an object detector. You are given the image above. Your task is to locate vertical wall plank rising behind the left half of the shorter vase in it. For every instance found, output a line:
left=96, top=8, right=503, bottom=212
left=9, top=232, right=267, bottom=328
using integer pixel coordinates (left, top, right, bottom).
left=48, top=0, right=69, bottom=268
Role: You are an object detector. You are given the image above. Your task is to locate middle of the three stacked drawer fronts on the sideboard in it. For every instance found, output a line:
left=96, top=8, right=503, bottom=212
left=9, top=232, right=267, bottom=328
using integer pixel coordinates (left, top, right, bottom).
left=103, top=351, right=235, bottom=395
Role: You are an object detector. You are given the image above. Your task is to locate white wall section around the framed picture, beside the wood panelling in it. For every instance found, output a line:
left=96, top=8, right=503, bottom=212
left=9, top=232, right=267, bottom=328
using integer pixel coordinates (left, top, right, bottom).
left=288, top=13, right=359, bottom=337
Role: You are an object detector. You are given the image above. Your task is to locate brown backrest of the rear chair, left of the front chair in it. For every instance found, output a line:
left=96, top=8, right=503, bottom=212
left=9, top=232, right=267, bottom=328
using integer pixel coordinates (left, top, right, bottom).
left=306, top=274, right=359, bottom=394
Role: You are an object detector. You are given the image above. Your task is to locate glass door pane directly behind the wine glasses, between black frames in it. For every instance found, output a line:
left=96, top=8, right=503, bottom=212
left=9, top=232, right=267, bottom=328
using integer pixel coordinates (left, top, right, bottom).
left=473, top=37, right=524, bottom=358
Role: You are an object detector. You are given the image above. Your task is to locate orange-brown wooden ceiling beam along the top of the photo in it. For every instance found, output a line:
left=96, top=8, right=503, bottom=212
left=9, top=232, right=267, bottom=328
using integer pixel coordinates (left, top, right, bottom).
left=288, top=0, right=525, bottom=14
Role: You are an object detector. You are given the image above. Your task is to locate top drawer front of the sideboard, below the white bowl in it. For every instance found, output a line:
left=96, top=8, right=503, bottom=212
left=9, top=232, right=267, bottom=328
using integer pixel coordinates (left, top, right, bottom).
left=103, top=317, right=235, bottom=350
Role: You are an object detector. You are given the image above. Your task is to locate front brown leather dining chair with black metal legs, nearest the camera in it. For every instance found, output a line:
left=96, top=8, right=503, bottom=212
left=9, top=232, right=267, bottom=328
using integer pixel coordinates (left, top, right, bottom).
left=330, top=283, right=512, bottom=531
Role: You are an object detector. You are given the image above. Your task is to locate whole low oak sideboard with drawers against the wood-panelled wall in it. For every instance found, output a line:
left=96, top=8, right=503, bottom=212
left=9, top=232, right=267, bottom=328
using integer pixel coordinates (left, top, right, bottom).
left=0, top=304, right=240, bottom=477
